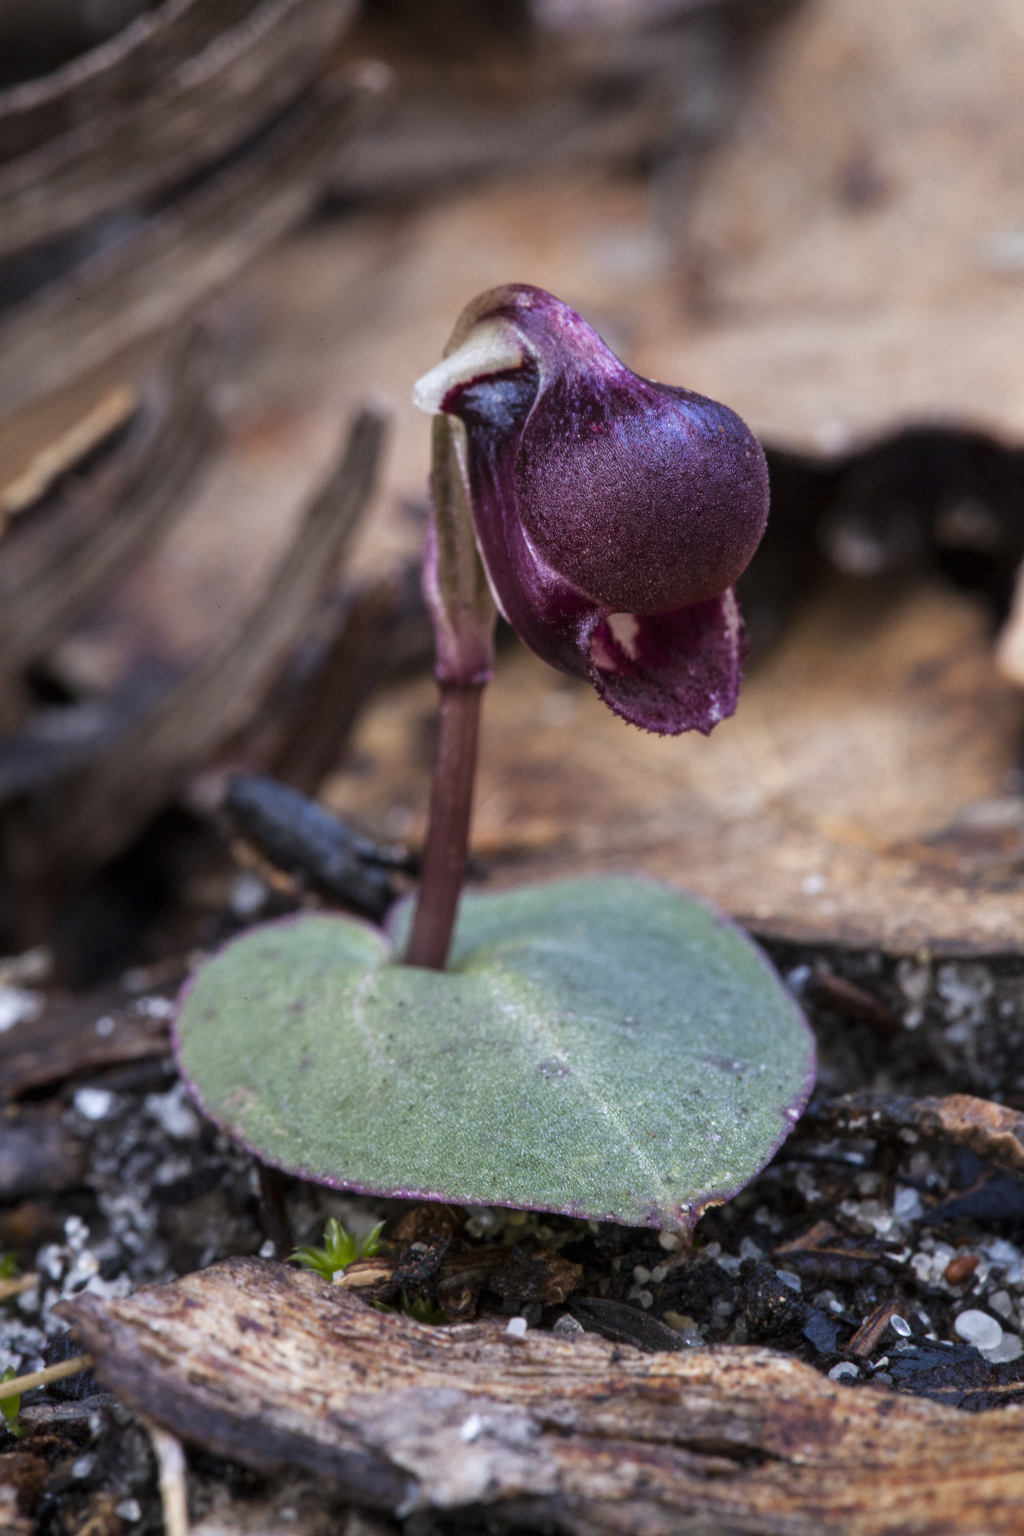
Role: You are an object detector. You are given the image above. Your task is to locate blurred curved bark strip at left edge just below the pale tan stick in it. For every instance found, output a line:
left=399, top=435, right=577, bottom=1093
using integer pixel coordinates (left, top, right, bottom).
left=0, top=329, right=218, bottom=691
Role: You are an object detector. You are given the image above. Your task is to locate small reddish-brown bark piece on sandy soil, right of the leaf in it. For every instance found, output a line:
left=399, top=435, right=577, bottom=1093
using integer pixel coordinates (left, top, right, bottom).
left=814, top=1092, right=1024, bottom=1178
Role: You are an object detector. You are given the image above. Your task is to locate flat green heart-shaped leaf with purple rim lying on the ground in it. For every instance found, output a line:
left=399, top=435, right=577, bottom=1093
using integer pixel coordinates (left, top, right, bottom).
left=177, top=877, right=814, bottom=1229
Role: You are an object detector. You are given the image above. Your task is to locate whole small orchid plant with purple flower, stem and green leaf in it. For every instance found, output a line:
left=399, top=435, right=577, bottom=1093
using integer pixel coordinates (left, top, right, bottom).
left=175, top=284, right=814, bottom=1234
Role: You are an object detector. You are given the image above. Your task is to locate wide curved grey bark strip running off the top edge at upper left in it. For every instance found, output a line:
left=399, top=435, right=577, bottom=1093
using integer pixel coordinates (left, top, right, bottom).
left=0, top=0, right=355, bottom=257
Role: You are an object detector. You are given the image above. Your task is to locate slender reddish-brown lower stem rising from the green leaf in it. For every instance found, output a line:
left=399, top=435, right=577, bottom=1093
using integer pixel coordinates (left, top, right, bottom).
left=405, top=682, right=484, bottom=971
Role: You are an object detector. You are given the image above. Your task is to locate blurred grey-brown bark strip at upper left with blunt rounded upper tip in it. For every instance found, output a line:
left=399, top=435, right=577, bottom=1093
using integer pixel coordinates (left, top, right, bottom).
left=0, top=69, right=379, bottom=415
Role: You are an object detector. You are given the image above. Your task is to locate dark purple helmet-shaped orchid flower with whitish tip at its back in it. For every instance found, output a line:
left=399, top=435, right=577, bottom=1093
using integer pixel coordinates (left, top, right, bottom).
left=413, top=283, right=768, bottom=736
